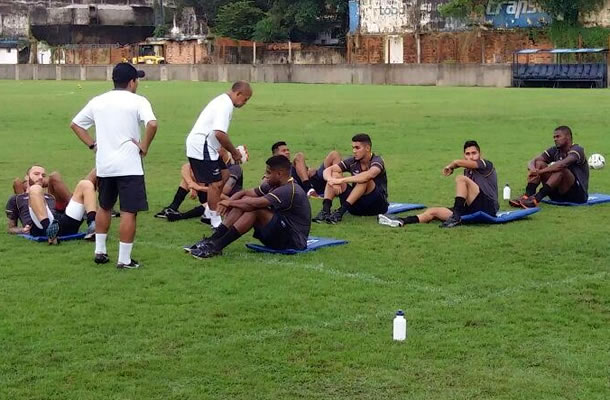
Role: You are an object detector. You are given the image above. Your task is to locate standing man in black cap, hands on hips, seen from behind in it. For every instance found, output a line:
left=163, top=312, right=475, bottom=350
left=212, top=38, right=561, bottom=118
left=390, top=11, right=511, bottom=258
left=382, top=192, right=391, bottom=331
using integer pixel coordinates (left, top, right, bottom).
left=70, top=63, right=157, bottom=269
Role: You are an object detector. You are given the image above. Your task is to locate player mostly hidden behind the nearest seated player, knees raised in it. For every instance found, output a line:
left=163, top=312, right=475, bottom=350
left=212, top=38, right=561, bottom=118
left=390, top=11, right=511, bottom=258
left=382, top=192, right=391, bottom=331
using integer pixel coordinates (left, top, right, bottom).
left=271, top=141, right=341, bottom=197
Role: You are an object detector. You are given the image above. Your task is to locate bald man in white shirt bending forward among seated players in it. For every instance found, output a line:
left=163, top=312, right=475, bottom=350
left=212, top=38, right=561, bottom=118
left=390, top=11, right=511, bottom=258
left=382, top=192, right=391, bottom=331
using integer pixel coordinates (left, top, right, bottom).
left=186, top=81, right=252, bottom=228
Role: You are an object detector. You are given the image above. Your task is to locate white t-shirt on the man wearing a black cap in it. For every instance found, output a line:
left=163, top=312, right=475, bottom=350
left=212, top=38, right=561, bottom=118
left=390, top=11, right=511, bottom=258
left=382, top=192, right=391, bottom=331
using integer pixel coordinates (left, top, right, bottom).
left=72, top=90, right=157, bottom=177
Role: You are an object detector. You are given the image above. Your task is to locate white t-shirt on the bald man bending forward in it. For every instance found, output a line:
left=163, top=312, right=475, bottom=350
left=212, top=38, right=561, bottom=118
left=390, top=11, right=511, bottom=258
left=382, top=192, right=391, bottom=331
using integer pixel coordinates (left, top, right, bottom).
left=186, top=93, right=235, bottom=160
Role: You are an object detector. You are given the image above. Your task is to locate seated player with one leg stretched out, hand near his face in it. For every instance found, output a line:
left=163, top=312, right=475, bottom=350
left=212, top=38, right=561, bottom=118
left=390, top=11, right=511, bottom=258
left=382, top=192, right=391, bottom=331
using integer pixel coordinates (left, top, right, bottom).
left=378, top=140, right=500, bottom=228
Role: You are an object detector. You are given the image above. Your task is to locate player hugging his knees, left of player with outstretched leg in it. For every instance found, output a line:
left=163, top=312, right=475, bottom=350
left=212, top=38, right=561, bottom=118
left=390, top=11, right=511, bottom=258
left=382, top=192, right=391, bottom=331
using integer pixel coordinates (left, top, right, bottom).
left=313, top=133, right=389, bottom=224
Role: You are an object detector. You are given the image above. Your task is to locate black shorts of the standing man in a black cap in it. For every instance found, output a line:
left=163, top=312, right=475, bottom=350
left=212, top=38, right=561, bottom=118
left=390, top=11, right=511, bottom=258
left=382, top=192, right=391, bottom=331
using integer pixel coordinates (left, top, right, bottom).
left=97, top=175, right=148, bottom=214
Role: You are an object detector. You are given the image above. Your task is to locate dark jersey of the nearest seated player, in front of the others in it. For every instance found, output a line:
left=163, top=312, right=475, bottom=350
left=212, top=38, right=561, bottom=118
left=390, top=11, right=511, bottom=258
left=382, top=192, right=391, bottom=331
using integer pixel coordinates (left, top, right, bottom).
left=256, top=179, right=311, bottom=249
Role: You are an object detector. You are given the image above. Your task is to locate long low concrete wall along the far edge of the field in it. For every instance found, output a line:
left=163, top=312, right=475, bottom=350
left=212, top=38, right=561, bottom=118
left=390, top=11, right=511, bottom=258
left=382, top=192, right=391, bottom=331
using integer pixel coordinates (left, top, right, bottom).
left=0, top=64, right=511, bottom=87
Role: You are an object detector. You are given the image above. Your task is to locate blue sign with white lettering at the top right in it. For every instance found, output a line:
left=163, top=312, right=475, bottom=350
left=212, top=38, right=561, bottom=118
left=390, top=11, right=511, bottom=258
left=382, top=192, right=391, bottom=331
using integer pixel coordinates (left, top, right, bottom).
left=485, top=0, right=551, bottom=28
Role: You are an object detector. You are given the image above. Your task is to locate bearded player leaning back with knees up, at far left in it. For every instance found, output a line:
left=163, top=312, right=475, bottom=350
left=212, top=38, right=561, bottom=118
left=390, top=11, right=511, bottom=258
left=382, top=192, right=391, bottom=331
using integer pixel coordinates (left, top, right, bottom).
left=6, top=165, right=97, bottom=244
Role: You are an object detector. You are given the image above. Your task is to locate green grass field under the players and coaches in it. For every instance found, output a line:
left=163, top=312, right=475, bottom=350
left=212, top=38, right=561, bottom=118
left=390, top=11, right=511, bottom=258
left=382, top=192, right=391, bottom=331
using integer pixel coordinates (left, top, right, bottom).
left=0, top=81, right=610, bottom=400
